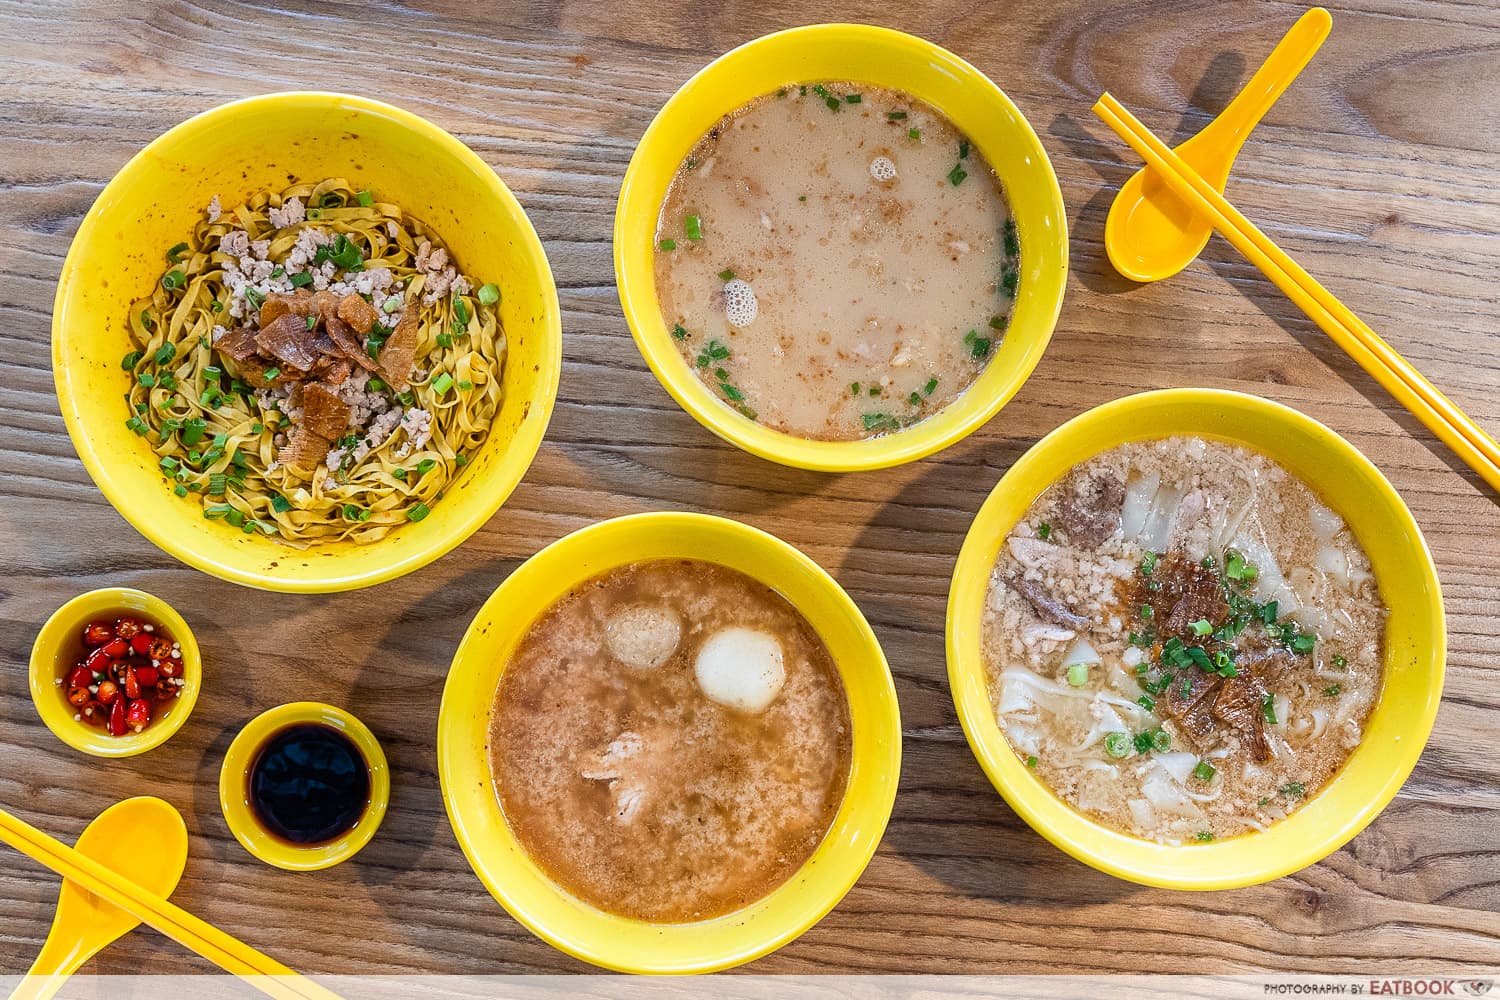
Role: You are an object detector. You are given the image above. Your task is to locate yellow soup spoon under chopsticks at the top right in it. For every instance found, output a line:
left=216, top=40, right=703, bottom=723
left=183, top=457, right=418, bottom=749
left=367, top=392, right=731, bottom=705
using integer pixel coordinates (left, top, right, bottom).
left=1104, top=7, right=1334, bottom=282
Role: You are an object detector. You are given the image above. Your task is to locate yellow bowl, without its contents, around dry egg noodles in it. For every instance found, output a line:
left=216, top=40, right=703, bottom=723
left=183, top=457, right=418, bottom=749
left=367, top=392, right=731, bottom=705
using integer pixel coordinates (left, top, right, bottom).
left=53, top=93, right=563, bottom=592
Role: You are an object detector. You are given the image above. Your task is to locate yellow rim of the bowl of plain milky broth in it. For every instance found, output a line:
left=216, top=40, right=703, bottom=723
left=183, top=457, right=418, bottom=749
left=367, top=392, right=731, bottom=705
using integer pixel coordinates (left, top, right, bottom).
left=612, top=22, right=1070, bottom=472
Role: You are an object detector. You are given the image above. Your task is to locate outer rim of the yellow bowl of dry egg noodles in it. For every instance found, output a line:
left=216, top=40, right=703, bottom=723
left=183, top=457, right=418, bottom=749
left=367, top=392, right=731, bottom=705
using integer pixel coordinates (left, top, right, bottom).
left=51, top=90, right=563, bottom=594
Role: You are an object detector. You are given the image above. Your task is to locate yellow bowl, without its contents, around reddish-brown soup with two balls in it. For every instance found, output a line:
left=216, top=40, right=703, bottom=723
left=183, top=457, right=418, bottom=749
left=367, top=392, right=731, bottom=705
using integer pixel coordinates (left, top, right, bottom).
left=438, top=513, right=902, bottom=975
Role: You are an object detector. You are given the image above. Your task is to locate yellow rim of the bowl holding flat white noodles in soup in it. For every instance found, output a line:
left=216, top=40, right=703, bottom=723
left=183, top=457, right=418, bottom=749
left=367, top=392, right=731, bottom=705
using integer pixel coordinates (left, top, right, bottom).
left=945, top=388, right=1448, bottom=891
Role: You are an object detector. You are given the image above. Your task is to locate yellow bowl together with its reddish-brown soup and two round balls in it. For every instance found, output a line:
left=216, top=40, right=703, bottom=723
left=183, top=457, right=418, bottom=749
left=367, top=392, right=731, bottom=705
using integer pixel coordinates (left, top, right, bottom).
left=438, top=513, right=902, bottom=973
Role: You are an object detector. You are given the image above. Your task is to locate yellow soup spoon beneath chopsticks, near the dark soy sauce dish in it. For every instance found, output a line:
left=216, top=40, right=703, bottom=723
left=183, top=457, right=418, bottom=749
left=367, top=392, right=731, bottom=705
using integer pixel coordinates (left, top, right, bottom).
left=11, top=796, right=188, bottom=1000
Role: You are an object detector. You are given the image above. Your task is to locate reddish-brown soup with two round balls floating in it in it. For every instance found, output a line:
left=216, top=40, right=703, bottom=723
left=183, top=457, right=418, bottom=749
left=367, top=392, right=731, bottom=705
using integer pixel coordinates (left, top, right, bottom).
left=489, top=559, right=851, bottom=922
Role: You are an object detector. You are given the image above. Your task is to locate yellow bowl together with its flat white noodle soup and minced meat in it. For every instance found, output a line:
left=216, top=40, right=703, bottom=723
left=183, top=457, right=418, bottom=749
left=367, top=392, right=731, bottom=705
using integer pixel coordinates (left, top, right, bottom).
left=948, top=388, right=1446, bottom=889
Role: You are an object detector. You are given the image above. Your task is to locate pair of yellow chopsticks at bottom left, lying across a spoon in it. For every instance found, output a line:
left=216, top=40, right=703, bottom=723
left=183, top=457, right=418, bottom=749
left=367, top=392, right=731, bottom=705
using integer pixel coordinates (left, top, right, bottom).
left=0, top=810, right=338, bottom=1000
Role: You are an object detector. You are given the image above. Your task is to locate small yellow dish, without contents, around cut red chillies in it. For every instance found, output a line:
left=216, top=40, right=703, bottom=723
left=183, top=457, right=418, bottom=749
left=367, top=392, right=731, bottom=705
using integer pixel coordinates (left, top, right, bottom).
left=32, top=586, right=203, bottom=757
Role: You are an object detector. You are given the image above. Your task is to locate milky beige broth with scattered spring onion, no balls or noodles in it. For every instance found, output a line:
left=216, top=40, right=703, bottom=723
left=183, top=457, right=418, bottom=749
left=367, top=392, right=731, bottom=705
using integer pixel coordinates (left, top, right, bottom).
left=656, top=82, right=1019, bottom=441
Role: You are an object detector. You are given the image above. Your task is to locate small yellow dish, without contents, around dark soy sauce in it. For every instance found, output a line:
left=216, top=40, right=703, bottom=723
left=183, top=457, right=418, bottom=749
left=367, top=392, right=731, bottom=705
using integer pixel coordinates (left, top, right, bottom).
left=219, top=702, right=390, bottom=871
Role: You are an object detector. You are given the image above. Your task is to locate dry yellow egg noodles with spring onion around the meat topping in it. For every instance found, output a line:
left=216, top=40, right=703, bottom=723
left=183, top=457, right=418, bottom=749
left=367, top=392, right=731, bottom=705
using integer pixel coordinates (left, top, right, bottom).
left=123, top=178, right=506, bottom=544
